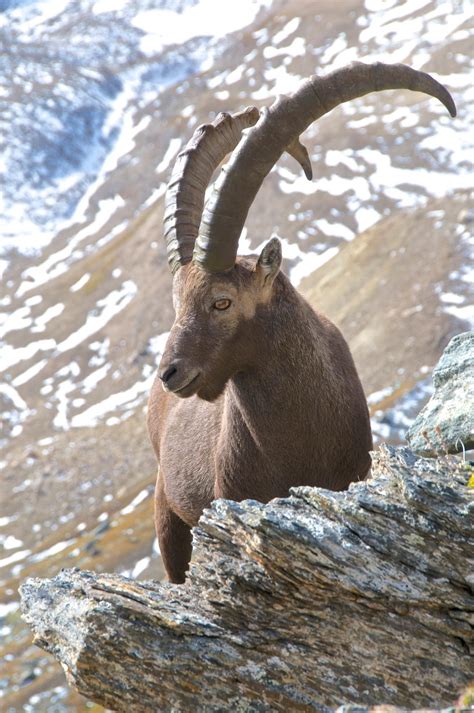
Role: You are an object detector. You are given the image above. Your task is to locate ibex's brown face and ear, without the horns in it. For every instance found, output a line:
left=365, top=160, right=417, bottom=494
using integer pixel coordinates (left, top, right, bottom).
left=159, top=238, right=281, bottom=401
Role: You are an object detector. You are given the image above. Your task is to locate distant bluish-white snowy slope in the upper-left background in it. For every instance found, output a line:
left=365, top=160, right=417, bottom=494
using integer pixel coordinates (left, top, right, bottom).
left=0, top=0, right=274, bottom=253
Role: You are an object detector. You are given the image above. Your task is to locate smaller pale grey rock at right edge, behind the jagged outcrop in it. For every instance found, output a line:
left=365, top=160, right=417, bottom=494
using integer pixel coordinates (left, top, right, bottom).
left=407, top=332, right=474, bottom=456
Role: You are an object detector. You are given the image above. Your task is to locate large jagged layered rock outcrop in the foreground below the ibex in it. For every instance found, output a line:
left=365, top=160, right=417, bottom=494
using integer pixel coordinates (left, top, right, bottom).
left=22, top=448, right=474, bottom=711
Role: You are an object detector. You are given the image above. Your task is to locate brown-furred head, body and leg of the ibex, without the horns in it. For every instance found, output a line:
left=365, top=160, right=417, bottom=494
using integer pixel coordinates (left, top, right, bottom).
left=148, top=248, right=372, bottom=582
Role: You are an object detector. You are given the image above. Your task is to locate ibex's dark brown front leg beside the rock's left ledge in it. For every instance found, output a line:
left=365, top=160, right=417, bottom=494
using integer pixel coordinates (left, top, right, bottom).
left=155, top=473, right=192, bottom=584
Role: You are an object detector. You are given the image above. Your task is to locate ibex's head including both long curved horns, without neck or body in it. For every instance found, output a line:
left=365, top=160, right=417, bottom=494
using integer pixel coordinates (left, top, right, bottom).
left=158, top=62, right=456, bottom=400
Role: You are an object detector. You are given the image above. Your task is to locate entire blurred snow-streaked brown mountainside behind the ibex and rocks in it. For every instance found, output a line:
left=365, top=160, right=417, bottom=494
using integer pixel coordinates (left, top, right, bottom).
left=0, top=0, right=474, bottom=712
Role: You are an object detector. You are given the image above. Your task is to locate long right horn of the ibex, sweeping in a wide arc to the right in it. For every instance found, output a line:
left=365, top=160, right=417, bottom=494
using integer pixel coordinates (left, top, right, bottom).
left=193, top=62, right=456, bottom=272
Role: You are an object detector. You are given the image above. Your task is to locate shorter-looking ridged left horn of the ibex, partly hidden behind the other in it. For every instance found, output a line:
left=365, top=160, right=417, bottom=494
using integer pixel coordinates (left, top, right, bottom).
left=164, top=107, right=259, bottom=274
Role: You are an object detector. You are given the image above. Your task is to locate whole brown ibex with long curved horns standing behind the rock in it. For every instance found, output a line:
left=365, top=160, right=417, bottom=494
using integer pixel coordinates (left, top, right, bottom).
left=148, top=63, right=456, bottom=582
